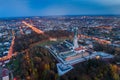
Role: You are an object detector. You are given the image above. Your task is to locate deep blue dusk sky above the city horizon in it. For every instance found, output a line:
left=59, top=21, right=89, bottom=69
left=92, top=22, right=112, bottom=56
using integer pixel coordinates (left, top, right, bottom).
left=0, top=0, right=120, bottom=17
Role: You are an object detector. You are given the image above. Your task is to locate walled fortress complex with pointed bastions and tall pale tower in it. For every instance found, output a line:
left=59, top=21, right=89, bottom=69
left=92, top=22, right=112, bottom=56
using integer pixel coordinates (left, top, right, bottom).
left=46, top=27, right=114, bottom=76
